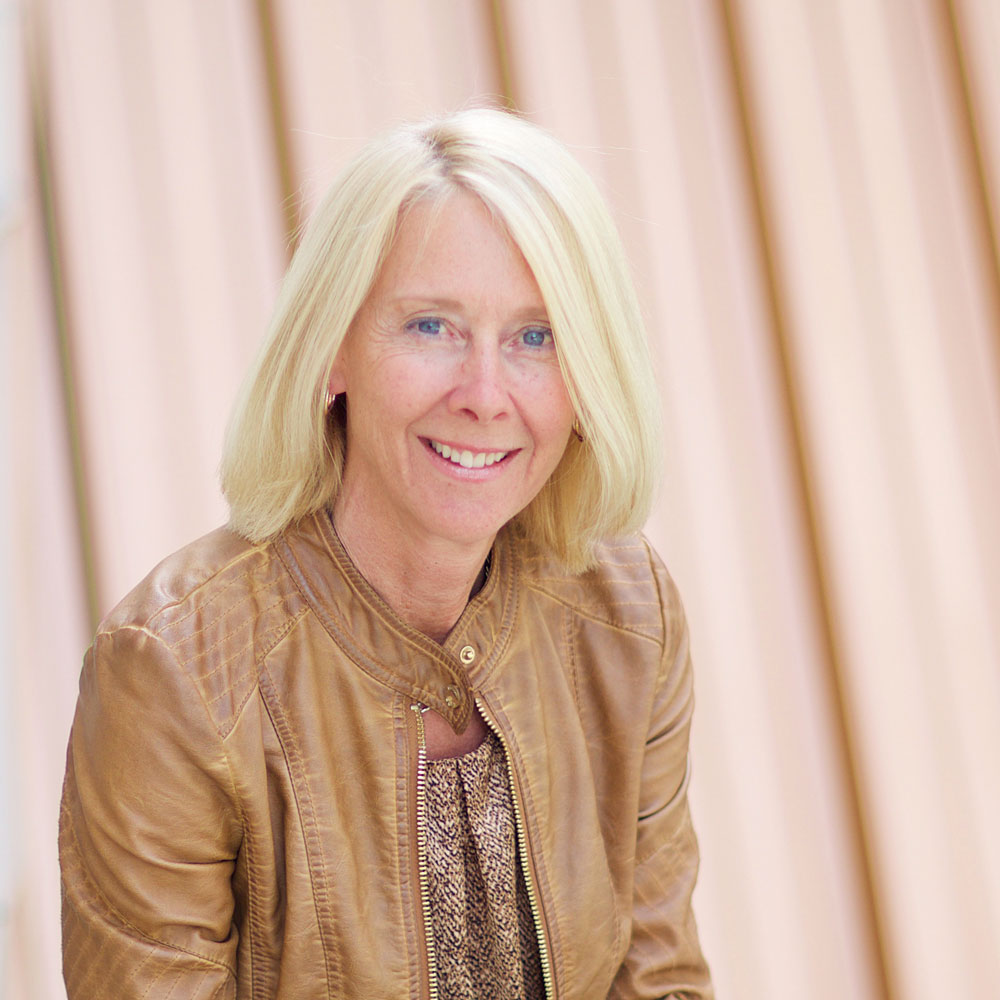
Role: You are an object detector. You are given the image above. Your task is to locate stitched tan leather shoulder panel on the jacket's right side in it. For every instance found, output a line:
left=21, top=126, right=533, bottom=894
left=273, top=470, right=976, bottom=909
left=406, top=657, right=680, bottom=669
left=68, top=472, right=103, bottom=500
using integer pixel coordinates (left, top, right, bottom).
left=521, top=535, right=665, bottom=644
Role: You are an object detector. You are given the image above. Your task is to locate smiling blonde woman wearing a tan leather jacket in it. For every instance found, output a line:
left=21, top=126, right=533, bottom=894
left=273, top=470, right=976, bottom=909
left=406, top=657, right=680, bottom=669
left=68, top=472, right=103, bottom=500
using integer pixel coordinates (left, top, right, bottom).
left=60, top=110, right=711, bottom=1000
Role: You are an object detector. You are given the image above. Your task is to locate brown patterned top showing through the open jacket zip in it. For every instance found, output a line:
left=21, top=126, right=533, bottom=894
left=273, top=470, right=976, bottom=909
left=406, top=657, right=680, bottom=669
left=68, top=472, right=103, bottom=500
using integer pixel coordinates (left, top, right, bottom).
left=427, top=733, right=544, bottom=1000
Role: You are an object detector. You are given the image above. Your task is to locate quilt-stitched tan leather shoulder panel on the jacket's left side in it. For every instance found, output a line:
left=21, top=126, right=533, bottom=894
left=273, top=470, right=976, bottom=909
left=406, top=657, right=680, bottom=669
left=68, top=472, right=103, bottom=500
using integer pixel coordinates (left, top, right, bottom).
left=99, top=528, right=306, bottom=735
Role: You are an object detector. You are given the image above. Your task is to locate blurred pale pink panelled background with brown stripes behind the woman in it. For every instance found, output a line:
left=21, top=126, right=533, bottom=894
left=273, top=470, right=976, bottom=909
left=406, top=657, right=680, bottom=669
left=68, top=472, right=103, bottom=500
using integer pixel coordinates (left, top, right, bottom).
left=0, top=0, right=1000, bottom=1000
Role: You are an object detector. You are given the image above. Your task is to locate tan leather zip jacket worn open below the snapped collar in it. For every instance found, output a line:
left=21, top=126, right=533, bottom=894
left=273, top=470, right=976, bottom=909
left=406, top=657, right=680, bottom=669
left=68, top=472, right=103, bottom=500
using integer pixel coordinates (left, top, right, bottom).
left=60, top=515, right=711, bottom=1000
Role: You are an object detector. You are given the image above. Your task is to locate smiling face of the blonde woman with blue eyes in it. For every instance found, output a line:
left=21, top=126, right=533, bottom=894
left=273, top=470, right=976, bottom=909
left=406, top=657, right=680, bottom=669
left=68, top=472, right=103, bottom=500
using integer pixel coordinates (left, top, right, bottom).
left=330, top=191, right=573, bottom=553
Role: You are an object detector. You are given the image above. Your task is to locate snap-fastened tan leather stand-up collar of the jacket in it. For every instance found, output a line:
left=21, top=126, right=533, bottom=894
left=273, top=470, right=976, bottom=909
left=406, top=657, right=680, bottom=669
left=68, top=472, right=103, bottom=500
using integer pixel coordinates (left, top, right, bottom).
left=276, top=510, right=517, bottom=732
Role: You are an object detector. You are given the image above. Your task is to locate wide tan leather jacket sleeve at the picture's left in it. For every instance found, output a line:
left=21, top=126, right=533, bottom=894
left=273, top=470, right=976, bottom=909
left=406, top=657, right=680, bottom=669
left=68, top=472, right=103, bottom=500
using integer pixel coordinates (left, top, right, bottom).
left=59, top=627, right=240, bottom=1000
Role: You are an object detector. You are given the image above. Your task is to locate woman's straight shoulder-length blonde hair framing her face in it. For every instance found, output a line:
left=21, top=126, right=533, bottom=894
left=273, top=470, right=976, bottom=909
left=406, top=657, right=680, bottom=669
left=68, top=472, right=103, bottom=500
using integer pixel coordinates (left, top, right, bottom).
left=227, top=108, right=660, bottom=570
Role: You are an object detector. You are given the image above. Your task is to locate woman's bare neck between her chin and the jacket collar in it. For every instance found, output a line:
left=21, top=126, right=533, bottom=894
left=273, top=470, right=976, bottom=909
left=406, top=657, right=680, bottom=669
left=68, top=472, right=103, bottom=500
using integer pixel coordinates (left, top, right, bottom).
left=333, top=498, right=493, bottom=642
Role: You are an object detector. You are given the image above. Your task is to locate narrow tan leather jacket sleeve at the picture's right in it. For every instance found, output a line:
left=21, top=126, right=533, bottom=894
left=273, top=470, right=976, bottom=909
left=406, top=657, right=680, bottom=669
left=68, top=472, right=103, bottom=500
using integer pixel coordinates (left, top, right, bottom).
left=609, top=555, right=714, bottom=1000
